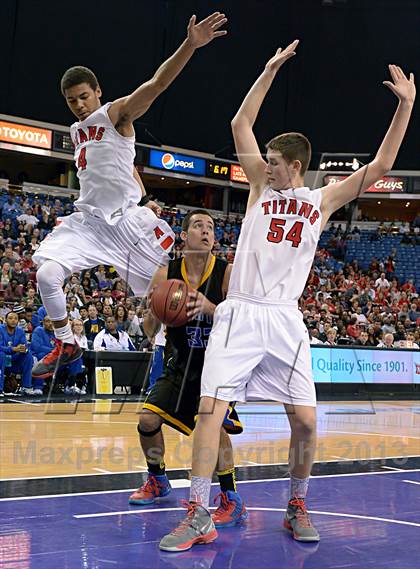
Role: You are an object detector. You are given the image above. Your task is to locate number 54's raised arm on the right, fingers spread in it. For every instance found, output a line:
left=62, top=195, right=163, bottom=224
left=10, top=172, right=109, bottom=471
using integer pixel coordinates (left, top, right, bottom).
left=321, top=65, right=416, bottom=221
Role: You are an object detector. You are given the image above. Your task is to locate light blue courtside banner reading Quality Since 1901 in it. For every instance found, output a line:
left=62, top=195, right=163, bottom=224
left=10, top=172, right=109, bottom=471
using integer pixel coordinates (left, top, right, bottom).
left=311, top=346, right=420, bottom=383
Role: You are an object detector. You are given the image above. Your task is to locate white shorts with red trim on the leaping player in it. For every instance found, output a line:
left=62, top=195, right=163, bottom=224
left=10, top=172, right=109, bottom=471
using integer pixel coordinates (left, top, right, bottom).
left=33, top=207, right=174, bottom=296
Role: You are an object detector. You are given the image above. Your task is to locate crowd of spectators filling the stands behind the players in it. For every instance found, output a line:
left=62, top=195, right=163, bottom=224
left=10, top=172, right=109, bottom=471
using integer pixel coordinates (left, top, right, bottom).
left=0, top=189, right=420, bottom=392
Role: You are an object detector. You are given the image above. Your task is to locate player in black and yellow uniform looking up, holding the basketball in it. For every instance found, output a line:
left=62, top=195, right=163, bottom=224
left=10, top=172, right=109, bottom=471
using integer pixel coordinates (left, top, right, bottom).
left=129, top=210, right=248, bottom=527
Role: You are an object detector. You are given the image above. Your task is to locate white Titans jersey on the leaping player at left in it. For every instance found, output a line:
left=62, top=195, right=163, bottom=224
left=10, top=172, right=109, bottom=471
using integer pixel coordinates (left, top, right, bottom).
left=70, top=103, right=141, bottom=225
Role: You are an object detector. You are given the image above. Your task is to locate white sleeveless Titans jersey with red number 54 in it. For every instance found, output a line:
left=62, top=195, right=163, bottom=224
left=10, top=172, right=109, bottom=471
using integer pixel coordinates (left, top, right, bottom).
left=227, top=187, right=322, bottom=303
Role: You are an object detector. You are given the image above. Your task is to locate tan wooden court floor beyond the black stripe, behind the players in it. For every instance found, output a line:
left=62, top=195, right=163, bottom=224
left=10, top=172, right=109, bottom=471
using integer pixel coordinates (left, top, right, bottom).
left=0, top=400, right=420, bottom=479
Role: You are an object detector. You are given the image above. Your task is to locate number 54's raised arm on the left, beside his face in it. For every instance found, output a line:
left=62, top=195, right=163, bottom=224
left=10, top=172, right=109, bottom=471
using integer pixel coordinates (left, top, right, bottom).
left=232, top=40, right=299, bottom=207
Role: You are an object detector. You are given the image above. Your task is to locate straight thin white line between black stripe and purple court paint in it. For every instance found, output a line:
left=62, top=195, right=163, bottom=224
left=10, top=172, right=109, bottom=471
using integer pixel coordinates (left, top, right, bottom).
left=0, top=468, right=420, bottom=502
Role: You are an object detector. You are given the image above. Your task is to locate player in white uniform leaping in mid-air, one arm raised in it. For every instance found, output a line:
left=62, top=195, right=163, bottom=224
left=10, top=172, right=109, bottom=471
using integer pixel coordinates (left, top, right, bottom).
left=33, top=12, right=227, bottom=377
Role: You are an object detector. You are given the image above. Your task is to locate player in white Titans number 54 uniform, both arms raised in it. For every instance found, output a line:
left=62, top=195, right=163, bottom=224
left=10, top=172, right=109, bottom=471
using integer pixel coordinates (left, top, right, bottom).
left=160, top=40, right=416, bottom=551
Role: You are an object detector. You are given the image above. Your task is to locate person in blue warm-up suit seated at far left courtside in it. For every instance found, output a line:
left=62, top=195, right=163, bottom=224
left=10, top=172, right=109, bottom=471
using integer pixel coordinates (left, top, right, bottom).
left=0, top=312, right=34, bottom=396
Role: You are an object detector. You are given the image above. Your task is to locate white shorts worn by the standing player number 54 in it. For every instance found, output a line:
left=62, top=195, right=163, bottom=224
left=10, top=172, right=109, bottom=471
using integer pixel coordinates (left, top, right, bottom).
left=201, top=298, right=316, bottom=407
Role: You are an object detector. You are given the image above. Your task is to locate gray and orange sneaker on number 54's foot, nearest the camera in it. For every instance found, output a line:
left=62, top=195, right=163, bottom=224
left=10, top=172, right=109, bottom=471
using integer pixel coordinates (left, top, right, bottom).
left=159, top=500, right=217, bottom=552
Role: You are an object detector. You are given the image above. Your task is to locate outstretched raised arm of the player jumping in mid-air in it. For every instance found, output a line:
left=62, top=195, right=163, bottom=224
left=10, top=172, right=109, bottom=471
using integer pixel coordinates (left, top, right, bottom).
left=109, top=12, right=227, bottom=125
